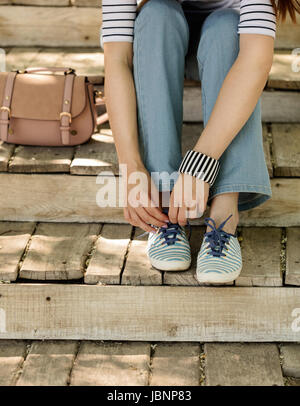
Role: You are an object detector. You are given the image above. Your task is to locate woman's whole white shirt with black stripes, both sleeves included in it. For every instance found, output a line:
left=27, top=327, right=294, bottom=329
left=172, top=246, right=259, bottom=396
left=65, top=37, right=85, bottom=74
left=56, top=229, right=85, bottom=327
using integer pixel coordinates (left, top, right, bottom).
left=101, top=0, right=276, bottom=42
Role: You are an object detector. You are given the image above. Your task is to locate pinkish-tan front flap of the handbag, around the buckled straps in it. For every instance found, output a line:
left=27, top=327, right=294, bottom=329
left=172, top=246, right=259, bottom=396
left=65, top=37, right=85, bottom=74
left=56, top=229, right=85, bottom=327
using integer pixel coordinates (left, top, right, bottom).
left=0, top=72, right=87, bottom=120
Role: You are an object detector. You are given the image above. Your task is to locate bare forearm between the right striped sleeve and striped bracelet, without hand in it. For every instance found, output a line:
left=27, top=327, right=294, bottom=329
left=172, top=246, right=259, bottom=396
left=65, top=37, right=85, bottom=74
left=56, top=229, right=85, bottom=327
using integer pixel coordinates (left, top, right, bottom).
left=194, top=34, right=274, bottom=159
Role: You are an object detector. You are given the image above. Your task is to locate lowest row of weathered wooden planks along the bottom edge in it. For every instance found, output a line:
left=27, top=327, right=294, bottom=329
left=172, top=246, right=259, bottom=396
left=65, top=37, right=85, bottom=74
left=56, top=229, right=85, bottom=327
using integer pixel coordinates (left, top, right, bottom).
left=0, top=340, right=300, bottom=384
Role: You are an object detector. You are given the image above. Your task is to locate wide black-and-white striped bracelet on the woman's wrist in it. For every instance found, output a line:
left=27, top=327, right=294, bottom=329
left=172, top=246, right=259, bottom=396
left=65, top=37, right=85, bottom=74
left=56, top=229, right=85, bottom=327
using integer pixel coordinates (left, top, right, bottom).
left=179, top=150, right=220, bottom=186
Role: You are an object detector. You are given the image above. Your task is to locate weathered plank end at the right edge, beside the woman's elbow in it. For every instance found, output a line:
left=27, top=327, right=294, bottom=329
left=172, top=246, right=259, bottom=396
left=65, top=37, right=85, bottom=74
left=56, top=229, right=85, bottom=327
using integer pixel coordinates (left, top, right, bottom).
left=267, top=50, right=300, bottom=89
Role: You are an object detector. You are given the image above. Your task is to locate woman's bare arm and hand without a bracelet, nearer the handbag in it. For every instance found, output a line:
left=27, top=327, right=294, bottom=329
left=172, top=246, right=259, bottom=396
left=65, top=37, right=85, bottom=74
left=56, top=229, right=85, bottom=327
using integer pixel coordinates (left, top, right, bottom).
left=104, top=42, right=168, bottom=232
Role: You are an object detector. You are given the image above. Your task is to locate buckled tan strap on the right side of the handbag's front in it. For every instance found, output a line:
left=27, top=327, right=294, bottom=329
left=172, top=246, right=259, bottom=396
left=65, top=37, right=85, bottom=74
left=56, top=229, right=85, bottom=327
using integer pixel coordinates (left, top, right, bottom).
left=60, top=74, right=75, bottom=145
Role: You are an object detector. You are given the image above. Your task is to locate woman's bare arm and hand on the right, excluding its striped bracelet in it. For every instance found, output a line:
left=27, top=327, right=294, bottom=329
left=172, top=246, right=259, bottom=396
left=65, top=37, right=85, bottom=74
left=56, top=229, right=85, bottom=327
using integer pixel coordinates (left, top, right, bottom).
left=169, top=34, right=274, bottom=225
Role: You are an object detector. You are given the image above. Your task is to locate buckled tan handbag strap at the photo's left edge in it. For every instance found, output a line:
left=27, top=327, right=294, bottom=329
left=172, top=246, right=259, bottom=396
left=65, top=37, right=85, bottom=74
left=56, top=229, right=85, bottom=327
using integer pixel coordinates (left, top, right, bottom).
left=0, top=72, right=17, bottom=141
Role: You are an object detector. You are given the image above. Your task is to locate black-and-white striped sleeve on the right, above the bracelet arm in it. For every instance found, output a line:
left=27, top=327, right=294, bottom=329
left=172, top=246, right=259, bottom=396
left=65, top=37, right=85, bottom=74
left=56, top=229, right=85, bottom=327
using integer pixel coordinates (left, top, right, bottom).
left=238, top=0, right=276, bottom=38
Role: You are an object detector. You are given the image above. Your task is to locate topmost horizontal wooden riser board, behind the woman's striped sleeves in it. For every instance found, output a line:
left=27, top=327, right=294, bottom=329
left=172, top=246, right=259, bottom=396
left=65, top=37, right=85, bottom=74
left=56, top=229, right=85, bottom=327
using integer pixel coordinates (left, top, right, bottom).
left=0, top=4, right=300, bottom=49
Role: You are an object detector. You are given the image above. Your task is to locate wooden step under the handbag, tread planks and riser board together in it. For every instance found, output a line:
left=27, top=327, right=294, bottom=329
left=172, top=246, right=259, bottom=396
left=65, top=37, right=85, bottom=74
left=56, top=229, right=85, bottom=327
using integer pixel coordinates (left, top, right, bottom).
left=0, top=124, right=300, bottom=226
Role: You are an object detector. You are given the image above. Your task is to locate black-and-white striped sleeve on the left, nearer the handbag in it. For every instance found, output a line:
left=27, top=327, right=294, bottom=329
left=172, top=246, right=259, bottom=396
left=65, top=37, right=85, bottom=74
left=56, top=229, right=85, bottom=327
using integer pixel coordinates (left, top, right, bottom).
left=101, top=0, right=137, bottom=43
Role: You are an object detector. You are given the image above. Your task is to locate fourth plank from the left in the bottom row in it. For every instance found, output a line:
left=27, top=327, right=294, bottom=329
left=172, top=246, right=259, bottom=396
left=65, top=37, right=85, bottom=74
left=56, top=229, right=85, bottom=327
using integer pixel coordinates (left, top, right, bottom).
left=150, top=343, right=200, bottom=386
